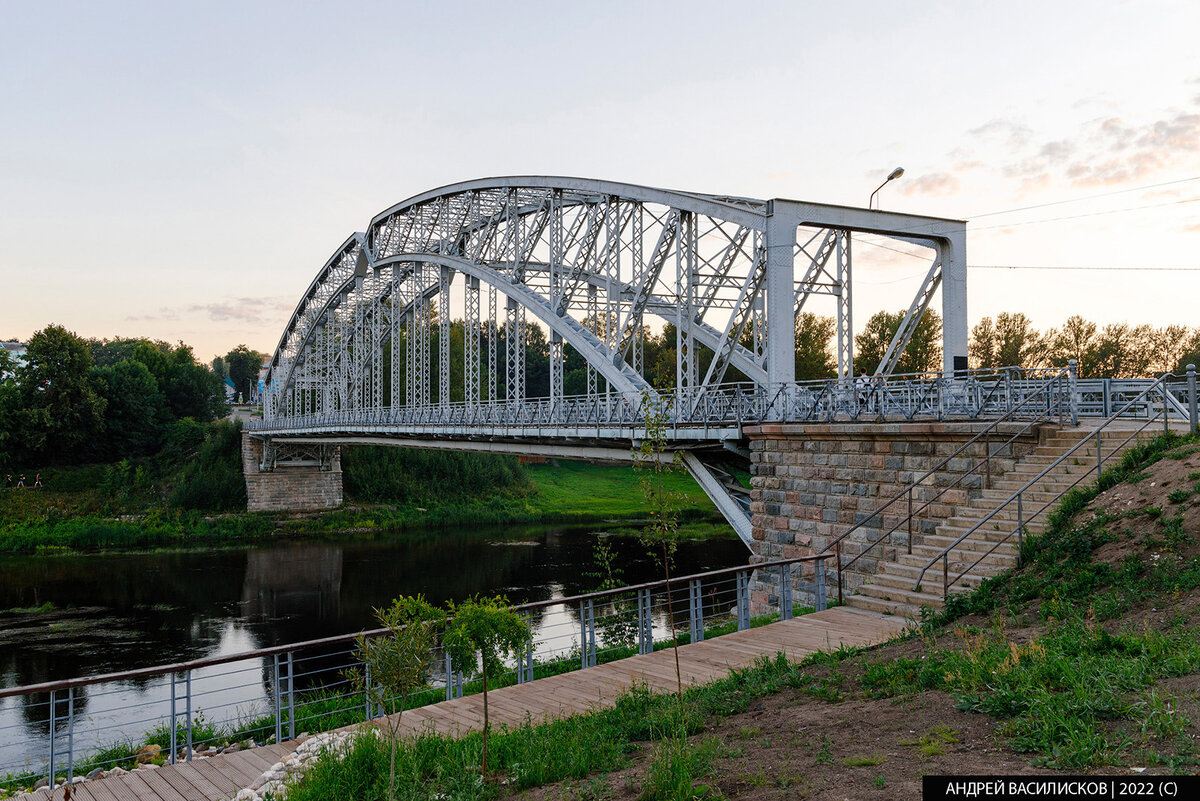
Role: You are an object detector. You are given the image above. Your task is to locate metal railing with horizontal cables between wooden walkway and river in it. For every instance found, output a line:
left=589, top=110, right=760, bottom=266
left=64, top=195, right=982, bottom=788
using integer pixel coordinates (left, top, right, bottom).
left=0, top=554, right=829, bottom=790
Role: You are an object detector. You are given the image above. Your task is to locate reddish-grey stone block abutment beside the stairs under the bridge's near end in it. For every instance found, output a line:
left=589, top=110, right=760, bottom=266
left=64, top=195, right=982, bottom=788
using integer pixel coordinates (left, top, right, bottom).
left=745, top=422, right=1045, bottom=608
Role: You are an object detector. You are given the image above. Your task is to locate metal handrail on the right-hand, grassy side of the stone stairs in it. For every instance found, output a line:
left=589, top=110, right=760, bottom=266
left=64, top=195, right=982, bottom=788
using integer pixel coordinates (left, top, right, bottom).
left=913, top=373, right=1180, bottom=598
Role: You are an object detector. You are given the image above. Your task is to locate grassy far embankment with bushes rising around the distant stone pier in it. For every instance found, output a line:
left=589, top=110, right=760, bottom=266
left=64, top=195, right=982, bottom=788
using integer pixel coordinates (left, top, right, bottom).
left=0, top=434, right=730, bottom=552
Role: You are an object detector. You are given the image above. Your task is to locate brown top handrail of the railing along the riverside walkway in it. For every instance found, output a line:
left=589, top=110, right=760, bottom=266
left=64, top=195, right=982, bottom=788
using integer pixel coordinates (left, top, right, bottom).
left=0, top=554, right=833, bottom=699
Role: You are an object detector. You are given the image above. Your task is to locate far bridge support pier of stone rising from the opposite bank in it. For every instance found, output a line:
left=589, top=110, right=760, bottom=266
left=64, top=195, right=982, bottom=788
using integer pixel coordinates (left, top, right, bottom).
left=241, top=432, right=342, bottom=512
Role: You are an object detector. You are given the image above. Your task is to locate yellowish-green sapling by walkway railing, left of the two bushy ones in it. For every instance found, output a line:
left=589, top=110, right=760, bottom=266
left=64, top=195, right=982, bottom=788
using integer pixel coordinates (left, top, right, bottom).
left=346, top=595, right=445, bottom=800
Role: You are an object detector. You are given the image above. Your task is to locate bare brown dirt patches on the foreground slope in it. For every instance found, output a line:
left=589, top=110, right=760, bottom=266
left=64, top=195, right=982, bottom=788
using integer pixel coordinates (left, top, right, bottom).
left=496, top=452, right=1200, bottom=801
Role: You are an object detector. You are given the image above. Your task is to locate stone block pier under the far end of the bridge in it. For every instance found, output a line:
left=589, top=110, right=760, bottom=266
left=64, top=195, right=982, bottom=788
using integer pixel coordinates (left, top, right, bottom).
left=241, top=433, right=342, bottom=512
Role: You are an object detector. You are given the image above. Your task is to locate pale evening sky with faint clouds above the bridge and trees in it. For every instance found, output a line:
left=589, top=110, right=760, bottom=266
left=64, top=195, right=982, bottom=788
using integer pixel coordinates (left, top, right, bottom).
left=0, top=0, right=1200, bottom=361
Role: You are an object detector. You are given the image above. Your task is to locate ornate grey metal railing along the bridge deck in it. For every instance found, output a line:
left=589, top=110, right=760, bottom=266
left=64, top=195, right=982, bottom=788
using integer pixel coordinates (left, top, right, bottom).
left=247, top=367, right=1104, bottom=432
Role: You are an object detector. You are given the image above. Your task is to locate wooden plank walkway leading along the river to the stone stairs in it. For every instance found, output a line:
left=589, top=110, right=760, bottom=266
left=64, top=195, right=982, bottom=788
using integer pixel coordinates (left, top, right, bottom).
left=14, top=607, right=905, bottom=801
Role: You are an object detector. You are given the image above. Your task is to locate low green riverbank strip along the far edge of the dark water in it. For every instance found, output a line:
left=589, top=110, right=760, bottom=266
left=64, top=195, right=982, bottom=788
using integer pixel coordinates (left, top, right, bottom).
left=0, top=462, right=731, bottom=553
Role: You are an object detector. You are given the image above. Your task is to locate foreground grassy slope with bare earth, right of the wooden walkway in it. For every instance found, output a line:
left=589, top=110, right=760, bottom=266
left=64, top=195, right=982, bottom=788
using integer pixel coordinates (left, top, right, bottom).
left=272, top=436, right=1200, bottom=801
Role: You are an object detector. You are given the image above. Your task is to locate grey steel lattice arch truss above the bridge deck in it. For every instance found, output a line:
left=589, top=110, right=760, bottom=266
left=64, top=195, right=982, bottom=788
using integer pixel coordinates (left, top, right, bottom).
left=265, top=181, right=955, bottom=416
